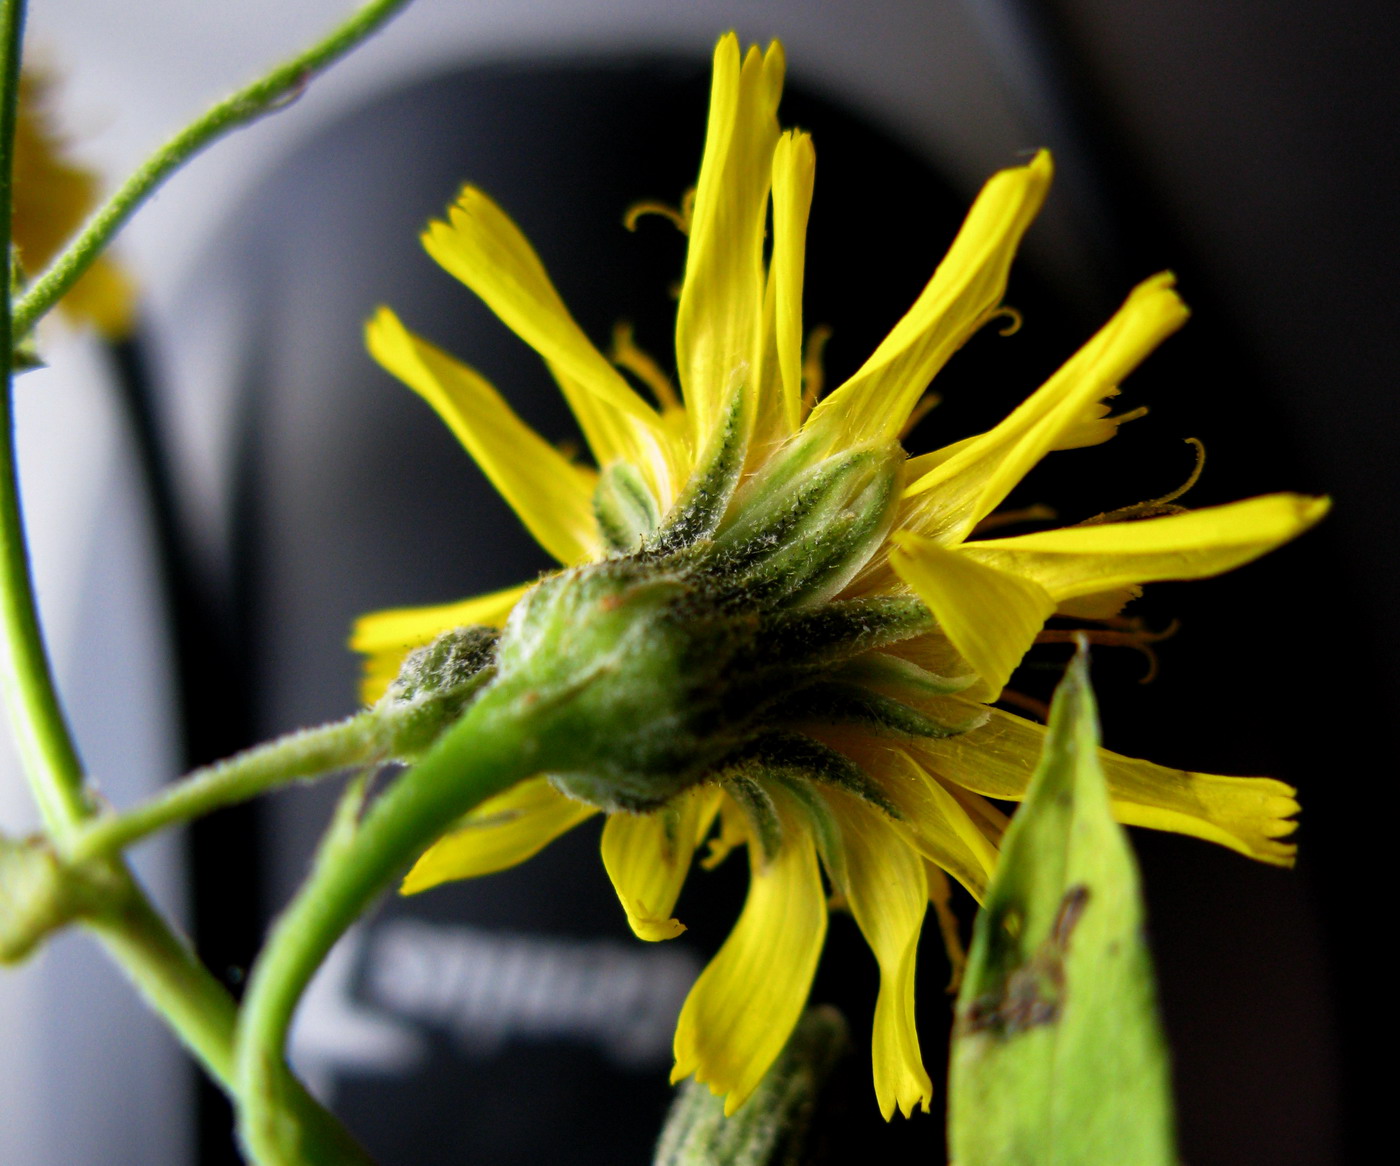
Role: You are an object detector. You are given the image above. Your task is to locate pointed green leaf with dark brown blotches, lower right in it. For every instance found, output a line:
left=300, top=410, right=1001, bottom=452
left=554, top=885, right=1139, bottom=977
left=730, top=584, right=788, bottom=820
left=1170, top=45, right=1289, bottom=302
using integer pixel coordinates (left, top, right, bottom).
left=948, top=647, right=1176, bottom=1166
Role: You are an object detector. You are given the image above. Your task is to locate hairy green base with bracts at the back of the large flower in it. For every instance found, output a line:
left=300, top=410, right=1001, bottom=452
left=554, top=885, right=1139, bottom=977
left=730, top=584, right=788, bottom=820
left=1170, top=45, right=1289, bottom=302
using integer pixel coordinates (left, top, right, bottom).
left=436, top=436, right=929, bottom=810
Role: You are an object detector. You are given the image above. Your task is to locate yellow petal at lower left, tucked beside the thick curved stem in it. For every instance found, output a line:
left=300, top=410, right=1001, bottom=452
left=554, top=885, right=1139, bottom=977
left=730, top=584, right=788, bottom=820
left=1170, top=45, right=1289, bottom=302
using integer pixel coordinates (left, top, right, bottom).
left=399, top=777, right=598, bottom=894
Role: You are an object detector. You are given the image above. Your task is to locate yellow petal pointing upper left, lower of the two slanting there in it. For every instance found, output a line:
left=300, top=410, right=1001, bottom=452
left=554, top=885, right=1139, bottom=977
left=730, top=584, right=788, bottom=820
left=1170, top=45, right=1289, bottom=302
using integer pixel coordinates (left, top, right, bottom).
left=365, top=308, right=598, bottom=567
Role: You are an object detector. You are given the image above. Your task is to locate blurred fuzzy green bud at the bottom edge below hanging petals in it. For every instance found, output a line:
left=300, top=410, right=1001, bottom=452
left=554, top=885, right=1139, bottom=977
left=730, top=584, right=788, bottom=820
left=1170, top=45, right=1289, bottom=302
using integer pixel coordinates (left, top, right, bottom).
left=652, top=1005, right=850, bottom=1166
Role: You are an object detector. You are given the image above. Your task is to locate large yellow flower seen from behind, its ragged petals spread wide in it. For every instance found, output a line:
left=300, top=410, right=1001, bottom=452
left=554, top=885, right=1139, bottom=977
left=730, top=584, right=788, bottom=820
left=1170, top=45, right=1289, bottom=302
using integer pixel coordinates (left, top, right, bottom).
left=353, top=34, right=1327, bottom=1117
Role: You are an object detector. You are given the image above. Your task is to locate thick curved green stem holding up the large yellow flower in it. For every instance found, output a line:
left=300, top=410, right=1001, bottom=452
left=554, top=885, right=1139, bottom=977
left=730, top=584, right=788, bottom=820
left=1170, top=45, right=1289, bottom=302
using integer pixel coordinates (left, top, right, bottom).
left=235, top=689, right=539, bottom=1166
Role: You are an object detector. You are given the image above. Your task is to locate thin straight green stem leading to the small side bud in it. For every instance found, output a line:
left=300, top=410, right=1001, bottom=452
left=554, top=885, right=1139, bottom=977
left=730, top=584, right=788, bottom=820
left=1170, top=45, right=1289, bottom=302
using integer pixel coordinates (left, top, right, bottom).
left=67, top=710, right=386, bottom=862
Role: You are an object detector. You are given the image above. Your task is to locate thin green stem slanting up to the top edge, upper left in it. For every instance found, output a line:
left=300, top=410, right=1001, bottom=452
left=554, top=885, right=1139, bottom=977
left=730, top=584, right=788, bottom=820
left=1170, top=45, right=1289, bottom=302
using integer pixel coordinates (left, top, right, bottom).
left=6, top=0, right=409, bottom=337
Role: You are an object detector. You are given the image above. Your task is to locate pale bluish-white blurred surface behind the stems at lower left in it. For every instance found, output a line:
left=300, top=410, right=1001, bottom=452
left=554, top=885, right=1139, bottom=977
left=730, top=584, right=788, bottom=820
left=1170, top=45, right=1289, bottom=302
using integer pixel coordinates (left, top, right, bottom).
left=0, top=337, right=192, bottom=1166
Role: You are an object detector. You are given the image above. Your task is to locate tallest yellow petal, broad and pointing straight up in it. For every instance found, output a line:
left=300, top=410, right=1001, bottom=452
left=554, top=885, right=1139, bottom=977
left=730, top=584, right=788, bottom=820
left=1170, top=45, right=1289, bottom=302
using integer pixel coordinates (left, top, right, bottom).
left=676, top=32, right=784, bottom=449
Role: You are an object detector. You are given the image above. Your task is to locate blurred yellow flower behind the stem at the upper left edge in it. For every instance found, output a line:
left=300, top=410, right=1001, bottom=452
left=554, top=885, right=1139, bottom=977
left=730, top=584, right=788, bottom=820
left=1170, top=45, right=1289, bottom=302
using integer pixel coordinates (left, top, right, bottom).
left=13, top=73, right=132, bottom=340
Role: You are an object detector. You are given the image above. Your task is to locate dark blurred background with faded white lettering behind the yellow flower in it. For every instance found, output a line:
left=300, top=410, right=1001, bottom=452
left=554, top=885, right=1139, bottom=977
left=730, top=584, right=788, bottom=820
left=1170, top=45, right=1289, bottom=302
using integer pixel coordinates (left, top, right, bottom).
left=8, top=0, right=1400, bottom=1166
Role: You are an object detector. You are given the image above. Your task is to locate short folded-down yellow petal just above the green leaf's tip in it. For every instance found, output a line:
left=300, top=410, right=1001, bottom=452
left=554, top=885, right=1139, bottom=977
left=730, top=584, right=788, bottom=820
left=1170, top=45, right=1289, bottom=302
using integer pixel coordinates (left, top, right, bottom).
left=889, top=531, right=1054, bottom=700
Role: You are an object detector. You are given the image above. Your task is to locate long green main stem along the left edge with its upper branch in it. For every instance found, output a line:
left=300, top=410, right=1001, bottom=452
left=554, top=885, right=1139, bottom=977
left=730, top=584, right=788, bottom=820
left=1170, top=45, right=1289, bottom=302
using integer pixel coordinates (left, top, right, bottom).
left=0, top=0, right=407, bottom=1163
